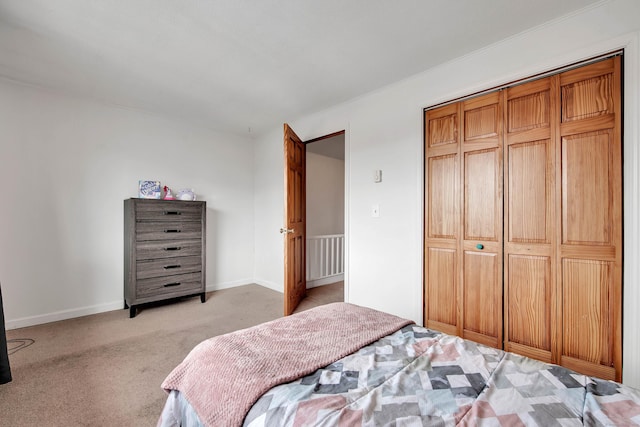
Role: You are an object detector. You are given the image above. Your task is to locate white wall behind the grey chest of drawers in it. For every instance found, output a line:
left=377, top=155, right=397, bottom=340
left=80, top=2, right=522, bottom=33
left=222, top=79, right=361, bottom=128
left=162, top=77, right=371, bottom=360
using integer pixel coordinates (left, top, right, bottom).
left=0, top=80, right=254, bottom=328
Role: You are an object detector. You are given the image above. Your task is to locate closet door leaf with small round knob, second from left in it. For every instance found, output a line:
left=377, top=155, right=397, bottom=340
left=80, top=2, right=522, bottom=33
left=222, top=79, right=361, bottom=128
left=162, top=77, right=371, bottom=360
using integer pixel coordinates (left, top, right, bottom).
left=460, top=92, right=503, bottom=347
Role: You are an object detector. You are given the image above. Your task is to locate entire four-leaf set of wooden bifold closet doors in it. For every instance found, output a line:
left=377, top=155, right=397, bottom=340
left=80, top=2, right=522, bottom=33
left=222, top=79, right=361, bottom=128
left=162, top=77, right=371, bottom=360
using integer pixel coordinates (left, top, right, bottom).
left=424, top=56, right=622, bottom=381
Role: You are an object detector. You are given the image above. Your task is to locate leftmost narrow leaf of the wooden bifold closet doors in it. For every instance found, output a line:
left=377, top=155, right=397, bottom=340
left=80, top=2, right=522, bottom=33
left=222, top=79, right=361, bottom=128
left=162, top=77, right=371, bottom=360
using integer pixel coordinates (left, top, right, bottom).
left=424, top=104, right=460, bottom=335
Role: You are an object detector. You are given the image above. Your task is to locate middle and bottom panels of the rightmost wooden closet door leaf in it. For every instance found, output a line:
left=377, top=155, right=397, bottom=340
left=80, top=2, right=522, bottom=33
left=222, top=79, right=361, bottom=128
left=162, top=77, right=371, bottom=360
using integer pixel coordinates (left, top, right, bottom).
left=560, top=129, right=622, bottom=380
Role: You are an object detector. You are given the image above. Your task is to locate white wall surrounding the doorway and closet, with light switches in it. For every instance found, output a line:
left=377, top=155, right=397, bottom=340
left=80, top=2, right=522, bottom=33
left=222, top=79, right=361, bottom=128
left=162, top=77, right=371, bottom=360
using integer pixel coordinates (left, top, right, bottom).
left=255, top=0, right=640, bottom=386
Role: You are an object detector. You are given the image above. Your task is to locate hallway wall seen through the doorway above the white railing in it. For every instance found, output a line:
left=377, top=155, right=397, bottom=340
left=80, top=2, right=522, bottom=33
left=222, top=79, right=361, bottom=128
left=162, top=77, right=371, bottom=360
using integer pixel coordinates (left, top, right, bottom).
left=306, top=152, right=344, bottom=236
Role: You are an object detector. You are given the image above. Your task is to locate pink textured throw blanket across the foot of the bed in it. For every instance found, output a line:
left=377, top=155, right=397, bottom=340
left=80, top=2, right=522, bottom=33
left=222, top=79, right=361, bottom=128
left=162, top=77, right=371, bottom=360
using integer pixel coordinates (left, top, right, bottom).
left=162, top=303, right=413, bottom=426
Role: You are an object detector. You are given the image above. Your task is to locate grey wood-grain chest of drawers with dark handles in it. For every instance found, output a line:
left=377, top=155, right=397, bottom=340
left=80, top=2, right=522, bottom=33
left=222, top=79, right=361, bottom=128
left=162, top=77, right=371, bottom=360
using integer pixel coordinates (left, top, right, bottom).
left=124, top=199, right=206, bottom=317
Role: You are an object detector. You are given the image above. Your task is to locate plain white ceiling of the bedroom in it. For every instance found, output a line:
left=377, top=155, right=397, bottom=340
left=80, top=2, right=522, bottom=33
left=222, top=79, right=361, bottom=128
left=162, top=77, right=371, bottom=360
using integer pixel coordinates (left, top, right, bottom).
left=0, top=0, right=601, bottom=137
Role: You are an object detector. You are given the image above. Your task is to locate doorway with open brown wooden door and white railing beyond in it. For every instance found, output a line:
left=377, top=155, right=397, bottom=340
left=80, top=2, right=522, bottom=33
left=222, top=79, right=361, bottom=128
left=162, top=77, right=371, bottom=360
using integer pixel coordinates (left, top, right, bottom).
left=281, top=124, right=345, bottom=315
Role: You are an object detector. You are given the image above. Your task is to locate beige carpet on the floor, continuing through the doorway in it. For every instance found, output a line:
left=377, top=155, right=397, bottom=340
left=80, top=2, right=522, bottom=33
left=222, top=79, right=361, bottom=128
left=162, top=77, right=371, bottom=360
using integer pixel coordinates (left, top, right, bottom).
left=0, top=282, right=344, bottom=426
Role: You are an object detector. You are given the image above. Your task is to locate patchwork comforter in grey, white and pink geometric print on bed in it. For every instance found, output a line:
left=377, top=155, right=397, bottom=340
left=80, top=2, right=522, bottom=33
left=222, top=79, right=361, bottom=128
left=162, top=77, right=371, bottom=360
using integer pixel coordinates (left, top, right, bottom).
left=162, top=310, right=640, bottom=427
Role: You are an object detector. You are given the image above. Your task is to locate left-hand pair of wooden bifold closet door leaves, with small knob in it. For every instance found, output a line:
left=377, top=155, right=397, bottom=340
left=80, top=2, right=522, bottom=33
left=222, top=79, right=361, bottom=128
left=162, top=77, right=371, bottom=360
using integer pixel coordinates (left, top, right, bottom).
left=424, top=93, right=502, bottom=347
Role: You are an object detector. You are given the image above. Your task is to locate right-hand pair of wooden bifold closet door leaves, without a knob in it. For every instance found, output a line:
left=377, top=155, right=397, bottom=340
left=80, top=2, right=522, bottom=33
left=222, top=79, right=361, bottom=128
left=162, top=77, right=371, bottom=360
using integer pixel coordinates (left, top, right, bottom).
left=504, top=57, right=622, bottom=381
